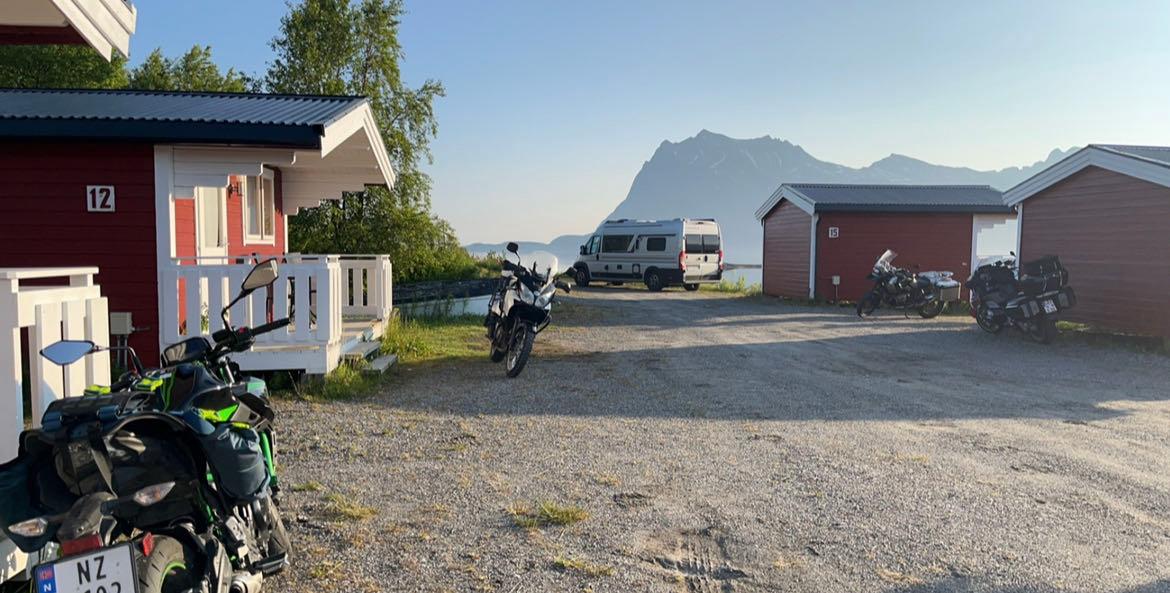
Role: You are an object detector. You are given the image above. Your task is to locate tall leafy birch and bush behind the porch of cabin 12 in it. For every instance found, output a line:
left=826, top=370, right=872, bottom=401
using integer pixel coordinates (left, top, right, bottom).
left=264, top=0, right=476, bottom=282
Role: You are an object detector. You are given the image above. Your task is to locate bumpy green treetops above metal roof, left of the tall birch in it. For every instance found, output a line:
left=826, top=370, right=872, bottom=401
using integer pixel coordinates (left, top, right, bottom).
left=128, top=46, right=255, bottom=92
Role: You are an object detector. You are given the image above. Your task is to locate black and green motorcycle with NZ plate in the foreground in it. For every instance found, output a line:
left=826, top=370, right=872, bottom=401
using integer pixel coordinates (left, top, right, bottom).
left=0, top=260, right=290, bottom=593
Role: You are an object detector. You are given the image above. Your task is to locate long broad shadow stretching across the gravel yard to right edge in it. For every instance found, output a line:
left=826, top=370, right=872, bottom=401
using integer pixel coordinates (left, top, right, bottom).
left=367, top=327, right=1170, bottom=429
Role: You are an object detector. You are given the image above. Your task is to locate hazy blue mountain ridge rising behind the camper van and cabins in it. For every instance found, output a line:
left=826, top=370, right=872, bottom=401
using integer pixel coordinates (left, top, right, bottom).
left=467, top=130, right=1072, bottom=264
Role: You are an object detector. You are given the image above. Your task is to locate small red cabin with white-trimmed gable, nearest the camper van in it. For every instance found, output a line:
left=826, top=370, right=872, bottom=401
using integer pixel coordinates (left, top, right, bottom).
left=756, top=184, right=1016, bottom=301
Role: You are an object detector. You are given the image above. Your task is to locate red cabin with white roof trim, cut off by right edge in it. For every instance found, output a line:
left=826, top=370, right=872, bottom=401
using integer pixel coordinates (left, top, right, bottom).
left=1004, top=145, right=1170, bottom=337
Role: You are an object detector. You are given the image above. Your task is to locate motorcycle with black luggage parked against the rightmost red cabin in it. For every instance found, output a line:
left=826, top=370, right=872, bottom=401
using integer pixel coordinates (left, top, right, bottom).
left=966, top=253, right=1076, bottom=344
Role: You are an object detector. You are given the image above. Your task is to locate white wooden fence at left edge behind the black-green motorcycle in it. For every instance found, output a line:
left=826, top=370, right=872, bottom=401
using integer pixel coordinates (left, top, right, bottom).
left=0, top=268, right=110, bottom=582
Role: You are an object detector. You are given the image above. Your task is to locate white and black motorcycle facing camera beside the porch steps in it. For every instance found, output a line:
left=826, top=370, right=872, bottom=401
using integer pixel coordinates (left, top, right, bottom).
left=483, top=243, right=571, bottom=378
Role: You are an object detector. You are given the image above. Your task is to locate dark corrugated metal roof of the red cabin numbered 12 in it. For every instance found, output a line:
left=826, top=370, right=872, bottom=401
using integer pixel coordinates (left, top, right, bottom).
left=0, top=89, right=366, bottom=147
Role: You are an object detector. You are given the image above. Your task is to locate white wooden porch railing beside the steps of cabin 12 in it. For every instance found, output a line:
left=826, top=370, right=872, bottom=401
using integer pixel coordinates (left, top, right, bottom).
left=159, top=254, right=392, bottom=374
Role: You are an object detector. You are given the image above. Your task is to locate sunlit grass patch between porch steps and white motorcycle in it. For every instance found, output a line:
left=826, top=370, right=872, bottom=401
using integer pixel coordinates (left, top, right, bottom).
left=381, top=315, right=488, bottom=363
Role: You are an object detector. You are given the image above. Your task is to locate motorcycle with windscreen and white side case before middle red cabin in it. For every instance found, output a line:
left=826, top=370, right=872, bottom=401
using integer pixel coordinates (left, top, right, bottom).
left=858, top=249, right=959, bottom=319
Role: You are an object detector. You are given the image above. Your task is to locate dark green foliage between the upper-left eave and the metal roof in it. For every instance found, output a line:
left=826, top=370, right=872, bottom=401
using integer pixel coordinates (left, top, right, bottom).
left=0, top=46, right=129, bottom=89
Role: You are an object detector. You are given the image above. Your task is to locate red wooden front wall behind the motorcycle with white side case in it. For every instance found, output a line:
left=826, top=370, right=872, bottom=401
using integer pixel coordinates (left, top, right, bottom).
left=817, top=212, right=971, bottom=301
